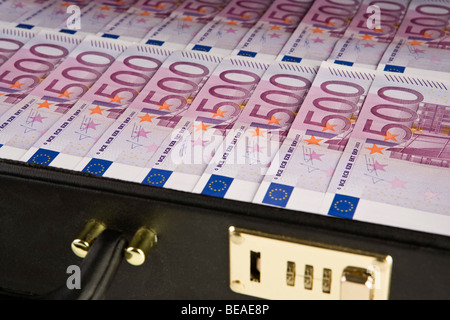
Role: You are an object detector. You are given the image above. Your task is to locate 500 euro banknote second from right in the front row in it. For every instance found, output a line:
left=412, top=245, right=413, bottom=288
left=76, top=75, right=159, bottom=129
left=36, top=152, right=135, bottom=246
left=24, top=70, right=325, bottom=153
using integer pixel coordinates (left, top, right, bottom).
left=253, top=62, right=375, bottom=213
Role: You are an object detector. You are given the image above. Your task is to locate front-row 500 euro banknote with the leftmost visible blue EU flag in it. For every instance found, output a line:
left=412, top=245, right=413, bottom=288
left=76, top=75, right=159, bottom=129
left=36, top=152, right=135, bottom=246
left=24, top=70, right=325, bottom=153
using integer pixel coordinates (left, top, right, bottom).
left=21, top=42, right=170, bottom=169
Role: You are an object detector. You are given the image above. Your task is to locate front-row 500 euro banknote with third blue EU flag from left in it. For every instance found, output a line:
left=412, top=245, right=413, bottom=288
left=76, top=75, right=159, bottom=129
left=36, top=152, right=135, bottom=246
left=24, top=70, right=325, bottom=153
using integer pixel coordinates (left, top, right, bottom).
left=135, top=57, right=268, bottom=191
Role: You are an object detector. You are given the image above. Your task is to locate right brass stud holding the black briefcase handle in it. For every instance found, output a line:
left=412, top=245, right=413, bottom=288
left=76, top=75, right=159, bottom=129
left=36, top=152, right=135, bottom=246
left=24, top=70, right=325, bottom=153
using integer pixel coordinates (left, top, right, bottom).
left=125, top=227, right=158, bottom=266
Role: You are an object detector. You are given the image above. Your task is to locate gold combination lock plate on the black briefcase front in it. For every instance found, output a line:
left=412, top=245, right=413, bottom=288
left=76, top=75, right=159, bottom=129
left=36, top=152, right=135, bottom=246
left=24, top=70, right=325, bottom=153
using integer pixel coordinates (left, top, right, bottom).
left=229, top=227, right=393, bottom=300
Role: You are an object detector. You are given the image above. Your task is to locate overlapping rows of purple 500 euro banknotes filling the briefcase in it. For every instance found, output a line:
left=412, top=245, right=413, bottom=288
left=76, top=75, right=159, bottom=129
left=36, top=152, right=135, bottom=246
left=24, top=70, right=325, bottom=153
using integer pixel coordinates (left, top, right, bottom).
left=0, top=0, right=450, bottom=235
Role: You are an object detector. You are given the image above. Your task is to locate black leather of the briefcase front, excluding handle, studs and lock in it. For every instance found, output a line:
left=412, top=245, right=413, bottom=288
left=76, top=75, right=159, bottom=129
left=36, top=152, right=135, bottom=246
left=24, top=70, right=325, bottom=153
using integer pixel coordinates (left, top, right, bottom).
left=0, top=161, right=450, bottom=300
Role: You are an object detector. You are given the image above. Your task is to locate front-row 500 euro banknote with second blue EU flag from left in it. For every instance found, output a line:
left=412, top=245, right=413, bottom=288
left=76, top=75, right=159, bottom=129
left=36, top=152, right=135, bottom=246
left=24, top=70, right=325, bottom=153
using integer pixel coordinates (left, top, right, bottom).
left=75, top=51, right=222, bottom=181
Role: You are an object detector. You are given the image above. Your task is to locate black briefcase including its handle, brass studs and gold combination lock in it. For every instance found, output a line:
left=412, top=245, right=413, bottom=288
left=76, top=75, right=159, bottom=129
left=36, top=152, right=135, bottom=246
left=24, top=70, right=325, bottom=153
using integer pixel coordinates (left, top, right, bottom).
left=0, top=160, right=450, bottom=300
